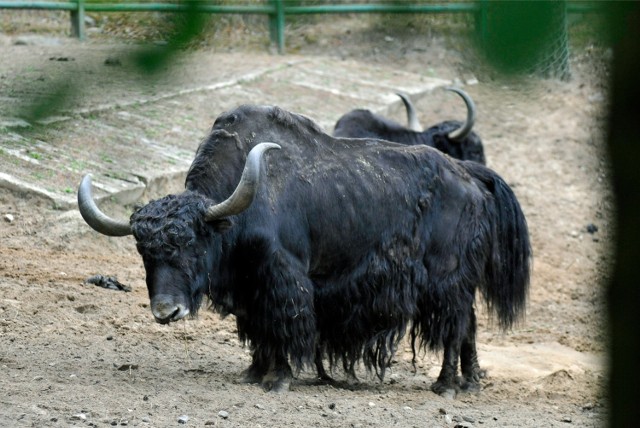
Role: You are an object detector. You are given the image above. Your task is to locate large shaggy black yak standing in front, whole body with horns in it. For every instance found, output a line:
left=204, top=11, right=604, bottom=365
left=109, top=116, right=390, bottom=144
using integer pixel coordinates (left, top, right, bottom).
left=78, top=106, right=531, bottom=395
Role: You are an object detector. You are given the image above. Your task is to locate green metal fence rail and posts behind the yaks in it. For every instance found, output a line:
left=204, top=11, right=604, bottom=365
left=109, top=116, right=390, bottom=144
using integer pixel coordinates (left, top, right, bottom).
left=0, top=0, right=596, bottom=53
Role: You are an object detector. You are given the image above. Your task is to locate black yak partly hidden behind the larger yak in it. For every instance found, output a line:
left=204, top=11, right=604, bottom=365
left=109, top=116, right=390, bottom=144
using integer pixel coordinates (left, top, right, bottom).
left=333, top=88, right=486, bottom=165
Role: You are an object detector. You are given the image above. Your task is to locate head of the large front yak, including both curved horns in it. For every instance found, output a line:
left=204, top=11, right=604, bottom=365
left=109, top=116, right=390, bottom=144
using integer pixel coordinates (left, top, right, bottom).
left=78, top=143, right=280, bottom=324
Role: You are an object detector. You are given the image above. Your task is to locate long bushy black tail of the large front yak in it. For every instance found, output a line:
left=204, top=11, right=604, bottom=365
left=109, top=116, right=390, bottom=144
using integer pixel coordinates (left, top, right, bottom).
left=465, top=161, right=532, bottom=330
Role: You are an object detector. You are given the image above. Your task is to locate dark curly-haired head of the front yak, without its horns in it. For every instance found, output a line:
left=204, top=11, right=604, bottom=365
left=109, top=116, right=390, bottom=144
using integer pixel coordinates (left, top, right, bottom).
left=130, top=191, right=222, bottom=324
